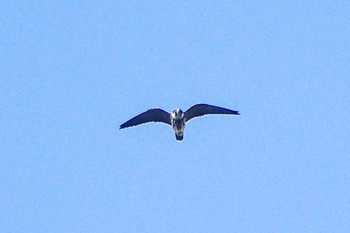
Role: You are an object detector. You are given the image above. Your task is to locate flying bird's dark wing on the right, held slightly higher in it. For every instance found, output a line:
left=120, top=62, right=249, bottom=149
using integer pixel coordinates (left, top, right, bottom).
left=185, top=104, right=239, bottom=121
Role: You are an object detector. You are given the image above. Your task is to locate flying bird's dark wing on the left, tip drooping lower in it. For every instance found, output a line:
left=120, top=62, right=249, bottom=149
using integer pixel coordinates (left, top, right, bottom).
left=119, top=108, right=171, bottom=129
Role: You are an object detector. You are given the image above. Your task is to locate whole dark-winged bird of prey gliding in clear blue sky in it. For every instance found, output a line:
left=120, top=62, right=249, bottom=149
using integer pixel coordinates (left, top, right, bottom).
left=120, top=104, right=240, bottom=141
